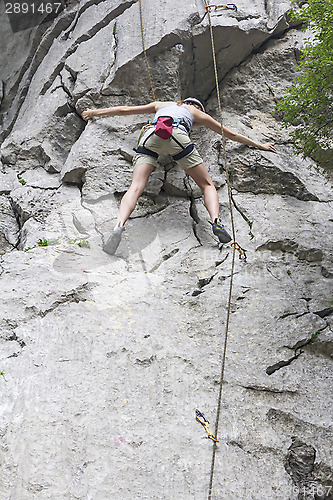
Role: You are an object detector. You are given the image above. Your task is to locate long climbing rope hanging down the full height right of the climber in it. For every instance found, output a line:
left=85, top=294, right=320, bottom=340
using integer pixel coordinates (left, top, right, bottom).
left=204, top=0, right=236, bottom=500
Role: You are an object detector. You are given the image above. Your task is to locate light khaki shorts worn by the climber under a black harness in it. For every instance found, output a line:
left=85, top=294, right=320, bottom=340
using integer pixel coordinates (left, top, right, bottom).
left=133, top=126, right=203, bottom=170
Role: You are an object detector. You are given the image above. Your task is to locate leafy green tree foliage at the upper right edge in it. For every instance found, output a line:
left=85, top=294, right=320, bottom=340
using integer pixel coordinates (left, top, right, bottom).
left=277, top=0, right=333, bottom=170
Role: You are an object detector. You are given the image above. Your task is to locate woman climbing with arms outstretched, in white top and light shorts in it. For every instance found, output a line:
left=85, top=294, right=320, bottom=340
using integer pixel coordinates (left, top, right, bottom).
left=82, top=97, right=277, bottom=255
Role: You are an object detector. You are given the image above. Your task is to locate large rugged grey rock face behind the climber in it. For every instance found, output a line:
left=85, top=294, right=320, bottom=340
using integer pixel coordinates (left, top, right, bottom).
left=0, top=0, right=333, bottom=500
